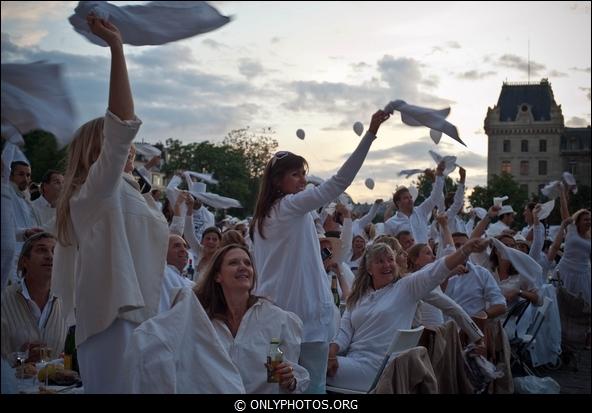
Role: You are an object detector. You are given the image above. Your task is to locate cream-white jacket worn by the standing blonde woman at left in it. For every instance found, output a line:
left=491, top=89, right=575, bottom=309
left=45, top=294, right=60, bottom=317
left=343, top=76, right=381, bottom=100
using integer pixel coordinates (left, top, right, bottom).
left=52, top=111, right=169, bottom=345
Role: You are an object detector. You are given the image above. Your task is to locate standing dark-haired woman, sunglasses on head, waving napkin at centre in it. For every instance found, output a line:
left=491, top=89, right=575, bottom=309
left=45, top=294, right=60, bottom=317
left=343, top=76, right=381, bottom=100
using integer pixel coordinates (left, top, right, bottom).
left=250, top=110, right=389, bottom=394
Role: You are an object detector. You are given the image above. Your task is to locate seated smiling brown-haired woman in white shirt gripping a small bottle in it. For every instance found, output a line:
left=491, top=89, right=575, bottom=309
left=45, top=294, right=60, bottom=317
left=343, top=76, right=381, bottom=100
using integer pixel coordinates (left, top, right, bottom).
left=196, top=244, right=310, bottom=393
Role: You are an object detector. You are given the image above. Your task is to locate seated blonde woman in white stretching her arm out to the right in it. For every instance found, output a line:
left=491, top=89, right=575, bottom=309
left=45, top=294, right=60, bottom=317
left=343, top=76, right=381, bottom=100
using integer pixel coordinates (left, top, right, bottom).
left=327, top=240, right=487, bottom=391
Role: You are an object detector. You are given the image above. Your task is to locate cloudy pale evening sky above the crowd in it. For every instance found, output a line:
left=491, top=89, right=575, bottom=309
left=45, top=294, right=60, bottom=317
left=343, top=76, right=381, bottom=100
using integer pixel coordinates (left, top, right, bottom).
left=1, top=1, right=591, bottom=202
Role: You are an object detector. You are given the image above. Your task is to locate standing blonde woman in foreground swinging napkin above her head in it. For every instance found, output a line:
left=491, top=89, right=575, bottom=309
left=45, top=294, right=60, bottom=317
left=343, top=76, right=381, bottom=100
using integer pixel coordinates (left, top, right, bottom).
left=52, top=15, right=169, bottom=393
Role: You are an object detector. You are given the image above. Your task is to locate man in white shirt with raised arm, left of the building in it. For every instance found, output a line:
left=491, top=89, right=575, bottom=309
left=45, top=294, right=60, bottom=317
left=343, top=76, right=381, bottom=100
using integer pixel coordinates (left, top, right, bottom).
left=384, top=162, right=446, bottom=244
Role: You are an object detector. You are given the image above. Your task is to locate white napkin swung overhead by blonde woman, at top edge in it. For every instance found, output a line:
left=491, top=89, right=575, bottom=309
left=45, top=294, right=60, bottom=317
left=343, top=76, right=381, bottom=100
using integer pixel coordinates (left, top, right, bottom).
left=68, top=1, right=230, bottom=46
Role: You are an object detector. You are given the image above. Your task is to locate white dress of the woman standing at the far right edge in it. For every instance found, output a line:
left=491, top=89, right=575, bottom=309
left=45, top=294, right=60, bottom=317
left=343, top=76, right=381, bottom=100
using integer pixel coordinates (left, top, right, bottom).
left=557, top=224, right=592, bottom=304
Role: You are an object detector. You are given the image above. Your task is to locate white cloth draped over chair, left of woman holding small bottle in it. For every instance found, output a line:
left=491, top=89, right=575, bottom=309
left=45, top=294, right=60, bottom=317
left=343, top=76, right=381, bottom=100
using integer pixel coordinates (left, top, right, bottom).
left=122, top=288, right=245, bottom=394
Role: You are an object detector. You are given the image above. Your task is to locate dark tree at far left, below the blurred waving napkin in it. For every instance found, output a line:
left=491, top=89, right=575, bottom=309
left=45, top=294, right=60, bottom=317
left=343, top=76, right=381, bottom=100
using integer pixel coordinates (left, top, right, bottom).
left=23, top=130, right=68, bottom=182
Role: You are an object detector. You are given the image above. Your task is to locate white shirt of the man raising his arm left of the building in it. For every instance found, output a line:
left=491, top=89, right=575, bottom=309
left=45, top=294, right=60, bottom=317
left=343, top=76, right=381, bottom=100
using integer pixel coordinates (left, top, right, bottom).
left=384, top=176, right=444, bottom=244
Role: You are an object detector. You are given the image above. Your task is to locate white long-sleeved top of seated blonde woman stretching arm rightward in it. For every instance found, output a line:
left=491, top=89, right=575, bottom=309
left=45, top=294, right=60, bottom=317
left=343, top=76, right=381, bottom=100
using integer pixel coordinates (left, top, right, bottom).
left=333, top=258, right=450, bottom=369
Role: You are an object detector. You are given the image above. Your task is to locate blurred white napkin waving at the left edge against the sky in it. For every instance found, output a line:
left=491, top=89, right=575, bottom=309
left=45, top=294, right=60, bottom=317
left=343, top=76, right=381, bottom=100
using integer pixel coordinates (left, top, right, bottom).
left=1, top=62, right=76, bottom=148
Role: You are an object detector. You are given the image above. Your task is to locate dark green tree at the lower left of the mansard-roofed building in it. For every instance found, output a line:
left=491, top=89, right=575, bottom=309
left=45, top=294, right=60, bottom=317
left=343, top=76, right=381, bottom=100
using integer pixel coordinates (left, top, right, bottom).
left=469, top=172, right=528, bottom=228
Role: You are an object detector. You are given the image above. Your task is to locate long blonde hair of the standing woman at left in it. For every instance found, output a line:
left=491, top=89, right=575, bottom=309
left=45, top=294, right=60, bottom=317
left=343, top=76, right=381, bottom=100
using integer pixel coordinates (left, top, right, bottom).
left=56, top=117, right=104, bottom=246
